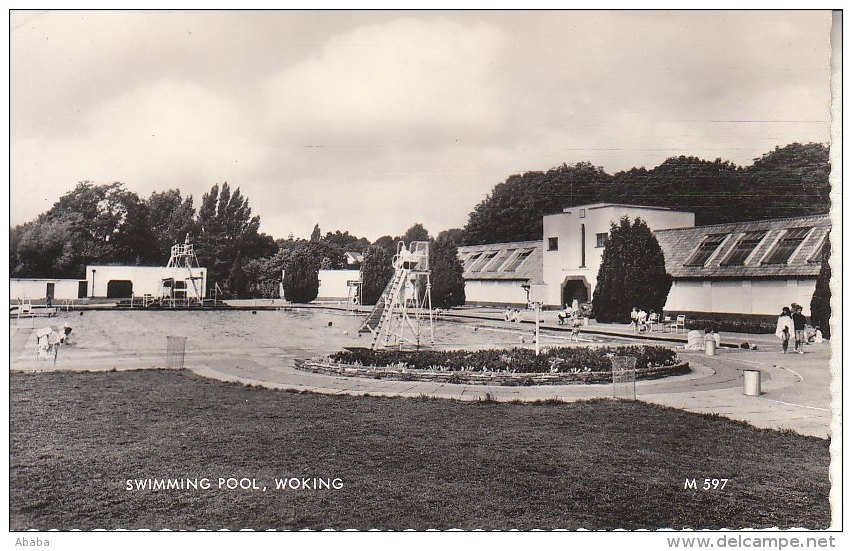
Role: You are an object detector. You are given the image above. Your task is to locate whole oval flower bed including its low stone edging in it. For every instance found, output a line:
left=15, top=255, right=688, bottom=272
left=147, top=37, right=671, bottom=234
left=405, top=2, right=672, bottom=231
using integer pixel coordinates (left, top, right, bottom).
left=296, top=346, right=689, bottom=386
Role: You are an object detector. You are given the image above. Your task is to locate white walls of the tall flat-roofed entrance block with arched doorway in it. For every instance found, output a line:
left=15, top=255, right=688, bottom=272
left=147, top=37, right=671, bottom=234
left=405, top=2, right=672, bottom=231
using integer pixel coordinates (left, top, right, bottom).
left=542, top=205, right=695, bottom=306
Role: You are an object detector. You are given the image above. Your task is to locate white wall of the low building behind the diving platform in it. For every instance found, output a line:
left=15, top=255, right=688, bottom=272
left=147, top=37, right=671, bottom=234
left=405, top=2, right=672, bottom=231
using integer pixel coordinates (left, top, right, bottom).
left=86, top=266, right=207, bottom=298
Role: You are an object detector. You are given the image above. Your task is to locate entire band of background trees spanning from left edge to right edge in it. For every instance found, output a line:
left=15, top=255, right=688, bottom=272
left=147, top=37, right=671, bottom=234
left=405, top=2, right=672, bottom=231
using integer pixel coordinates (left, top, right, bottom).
left=9, top=143, right=830, bottom=309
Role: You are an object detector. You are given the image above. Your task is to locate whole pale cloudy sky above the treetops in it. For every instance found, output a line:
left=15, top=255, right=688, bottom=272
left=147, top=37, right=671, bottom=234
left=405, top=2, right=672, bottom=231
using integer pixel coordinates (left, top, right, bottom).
left=10, top=11, right=831, bottom=240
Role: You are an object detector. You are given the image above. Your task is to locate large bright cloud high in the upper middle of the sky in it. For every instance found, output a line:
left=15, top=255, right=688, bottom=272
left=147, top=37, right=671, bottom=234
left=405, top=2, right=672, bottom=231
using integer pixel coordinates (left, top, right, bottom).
left=267, top=18, right=508, bottom=145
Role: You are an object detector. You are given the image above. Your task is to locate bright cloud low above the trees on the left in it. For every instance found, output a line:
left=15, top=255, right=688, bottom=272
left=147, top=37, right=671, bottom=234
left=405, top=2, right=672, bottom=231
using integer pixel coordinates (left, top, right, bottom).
left=11, top=80, right=259, bottom=218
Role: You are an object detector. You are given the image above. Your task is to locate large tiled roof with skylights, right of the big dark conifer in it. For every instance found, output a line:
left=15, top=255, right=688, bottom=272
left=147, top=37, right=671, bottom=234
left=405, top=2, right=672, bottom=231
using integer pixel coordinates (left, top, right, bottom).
left=654, top=214, right=831, bottom=279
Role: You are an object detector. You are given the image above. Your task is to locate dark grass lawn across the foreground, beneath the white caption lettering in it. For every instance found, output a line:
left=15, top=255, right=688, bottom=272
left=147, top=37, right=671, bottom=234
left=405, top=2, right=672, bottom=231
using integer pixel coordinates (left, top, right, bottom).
left=10, top=371, right=830, bottom=530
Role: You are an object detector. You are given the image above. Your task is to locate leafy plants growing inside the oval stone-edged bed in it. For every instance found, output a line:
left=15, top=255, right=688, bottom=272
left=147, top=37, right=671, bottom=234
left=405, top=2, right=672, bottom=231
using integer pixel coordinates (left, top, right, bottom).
left=329, top=346, right=679, bottom=373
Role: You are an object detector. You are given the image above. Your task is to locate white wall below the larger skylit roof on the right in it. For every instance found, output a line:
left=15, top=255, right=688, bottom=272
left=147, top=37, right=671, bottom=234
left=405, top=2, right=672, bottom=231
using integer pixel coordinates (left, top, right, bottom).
left=665, top=278, right=816, bottom=316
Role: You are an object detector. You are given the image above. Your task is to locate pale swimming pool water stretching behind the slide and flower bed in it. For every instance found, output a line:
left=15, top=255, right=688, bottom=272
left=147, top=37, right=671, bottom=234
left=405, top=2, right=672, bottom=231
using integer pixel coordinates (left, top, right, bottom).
left=10, top=307, right=652, bottom=370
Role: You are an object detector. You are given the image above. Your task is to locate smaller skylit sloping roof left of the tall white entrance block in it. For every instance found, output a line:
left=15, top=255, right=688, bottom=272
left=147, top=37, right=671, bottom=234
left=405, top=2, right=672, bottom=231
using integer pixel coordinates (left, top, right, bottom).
left=458, top=240, right=544, bottom=283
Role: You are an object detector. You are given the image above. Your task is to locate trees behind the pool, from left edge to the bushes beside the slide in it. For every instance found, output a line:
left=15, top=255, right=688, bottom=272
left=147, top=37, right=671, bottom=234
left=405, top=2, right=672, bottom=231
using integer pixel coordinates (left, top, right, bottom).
left=9, top=181, right=464, bottom=307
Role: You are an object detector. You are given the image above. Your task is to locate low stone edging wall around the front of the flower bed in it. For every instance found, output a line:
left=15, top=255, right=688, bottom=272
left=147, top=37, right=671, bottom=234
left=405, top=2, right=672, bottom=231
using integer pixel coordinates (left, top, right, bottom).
left=295, top=359, right=690, bottom=386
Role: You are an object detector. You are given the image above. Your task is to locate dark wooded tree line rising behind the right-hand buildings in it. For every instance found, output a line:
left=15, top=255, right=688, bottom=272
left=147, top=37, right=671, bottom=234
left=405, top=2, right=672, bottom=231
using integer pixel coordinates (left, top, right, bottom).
left=460, top=143, right=831, bottom=245
